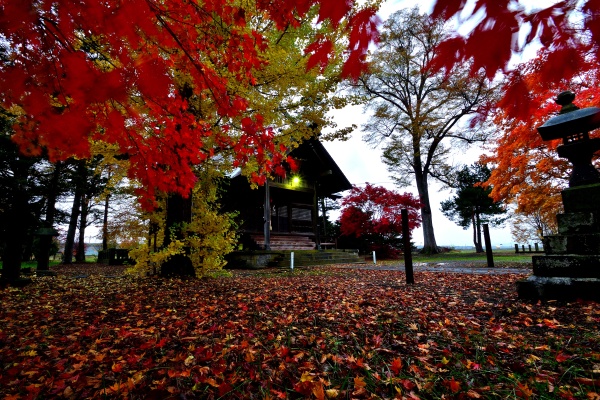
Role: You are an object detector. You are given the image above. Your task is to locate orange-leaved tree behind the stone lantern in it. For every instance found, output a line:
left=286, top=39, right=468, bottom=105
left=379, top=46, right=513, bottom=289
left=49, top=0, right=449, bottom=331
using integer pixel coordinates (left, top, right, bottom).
left=482, top=52, right=600, bottom=240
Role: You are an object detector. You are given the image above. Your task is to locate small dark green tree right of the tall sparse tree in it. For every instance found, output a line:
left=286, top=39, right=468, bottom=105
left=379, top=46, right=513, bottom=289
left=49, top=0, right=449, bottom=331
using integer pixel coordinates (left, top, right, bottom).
left=441, top=163, right=506, bottom=253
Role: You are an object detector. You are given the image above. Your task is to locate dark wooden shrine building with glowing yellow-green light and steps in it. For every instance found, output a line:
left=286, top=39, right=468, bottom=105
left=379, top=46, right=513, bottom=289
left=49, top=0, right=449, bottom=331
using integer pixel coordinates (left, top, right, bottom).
left=226, top=139, right=352, bottom=250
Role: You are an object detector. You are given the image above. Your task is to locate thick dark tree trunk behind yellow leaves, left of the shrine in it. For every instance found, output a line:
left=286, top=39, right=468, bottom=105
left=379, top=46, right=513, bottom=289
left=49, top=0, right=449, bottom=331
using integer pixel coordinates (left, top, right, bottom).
left=160, top=193, right=195, bottom=276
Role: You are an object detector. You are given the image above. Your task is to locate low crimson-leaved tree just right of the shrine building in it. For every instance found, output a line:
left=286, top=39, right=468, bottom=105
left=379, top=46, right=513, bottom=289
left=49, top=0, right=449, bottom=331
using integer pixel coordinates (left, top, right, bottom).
left=340, top=183, right=421, bottom=258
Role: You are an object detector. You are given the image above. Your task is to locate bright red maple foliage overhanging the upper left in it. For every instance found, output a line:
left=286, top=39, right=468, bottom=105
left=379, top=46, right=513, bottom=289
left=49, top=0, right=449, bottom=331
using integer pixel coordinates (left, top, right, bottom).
left=0, top=0, right=377, bottom=209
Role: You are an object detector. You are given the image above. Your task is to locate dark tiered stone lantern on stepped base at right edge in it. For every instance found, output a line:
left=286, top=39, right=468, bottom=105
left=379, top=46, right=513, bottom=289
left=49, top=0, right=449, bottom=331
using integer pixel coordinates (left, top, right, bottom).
left=517, top=91, right=600, bottom=300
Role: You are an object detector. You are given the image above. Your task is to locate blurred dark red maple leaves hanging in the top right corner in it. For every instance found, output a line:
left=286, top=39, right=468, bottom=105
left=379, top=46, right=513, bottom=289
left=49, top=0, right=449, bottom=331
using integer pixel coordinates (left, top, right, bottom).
left=432, top=0, right=600, bottom=118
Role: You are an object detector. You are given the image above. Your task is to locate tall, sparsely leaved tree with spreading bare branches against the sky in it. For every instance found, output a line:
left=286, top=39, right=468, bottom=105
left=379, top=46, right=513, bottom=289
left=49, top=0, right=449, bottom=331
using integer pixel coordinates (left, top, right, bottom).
left=353, top=9, right=492, bottom=252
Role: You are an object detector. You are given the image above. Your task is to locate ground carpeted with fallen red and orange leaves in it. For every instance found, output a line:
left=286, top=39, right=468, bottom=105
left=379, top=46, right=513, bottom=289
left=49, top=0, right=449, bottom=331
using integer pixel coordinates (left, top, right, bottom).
left=0, top=265, right=600, bottom=399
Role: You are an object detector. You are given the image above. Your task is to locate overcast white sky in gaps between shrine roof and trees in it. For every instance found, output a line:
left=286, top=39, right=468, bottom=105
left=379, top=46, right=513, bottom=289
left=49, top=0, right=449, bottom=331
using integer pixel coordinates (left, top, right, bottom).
left=324, top=0, right=514, bottom=247
